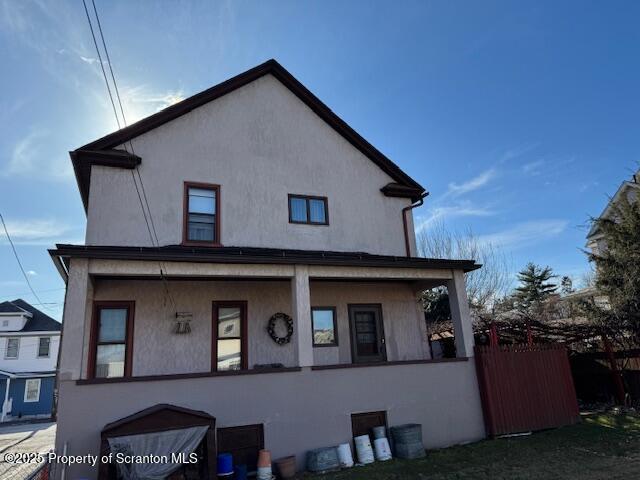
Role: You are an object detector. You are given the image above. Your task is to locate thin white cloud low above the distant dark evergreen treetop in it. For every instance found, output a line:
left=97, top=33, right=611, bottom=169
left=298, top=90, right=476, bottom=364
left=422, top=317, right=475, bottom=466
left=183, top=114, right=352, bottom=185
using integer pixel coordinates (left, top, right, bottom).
left=479, top=220, right=569, bottom=249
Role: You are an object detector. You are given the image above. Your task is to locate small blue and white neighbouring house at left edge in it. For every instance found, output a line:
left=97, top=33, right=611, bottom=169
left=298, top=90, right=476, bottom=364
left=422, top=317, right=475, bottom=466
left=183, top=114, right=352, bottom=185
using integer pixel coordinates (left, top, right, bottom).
left=0, top=299, right=61, bottom=422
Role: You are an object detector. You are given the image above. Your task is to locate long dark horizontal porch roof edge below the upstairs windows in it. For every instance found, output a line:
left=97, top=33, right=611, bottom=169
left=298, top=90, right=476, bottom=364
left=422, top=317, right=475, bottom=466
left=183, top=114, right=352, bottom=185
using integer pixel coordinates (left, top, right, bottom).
left=49, top=244, right=480, bottom=272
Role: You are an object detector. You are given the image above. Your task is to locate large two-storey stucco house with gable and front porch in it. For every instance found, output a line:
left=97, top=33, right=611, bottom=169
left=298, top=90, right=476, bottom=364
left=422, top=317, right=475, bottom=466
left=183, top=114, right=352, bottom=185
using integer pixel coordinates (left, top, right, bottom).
left=50, top=60, right=485, bottom=478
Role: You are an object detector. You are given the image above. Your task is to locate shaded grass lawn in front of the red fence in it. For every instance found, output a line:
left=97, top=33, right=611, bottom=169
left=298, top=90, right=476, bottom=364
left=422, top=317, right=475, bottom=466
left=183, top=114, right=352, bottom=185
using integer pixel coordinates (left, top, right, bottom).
left=300, top=414, right=640, bottom=480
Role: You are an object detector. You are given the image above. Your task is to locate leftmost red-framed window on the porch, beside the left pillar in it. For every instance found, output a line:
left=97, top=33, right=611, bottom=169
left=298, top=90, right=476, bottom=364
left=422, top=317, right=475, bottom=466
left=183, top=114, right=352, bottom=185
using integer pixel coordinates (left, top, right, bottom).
left=89, top=302, right=134, bottom=378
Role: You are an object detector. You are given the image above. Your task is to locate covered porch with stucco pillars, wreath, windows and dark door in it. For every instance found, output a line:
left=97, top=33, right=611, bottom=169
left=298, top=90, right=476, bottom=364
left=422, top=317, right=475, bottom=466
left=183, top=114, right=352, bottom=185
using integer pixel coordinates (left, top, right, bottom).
left=52, top=251, right=473, bottom=381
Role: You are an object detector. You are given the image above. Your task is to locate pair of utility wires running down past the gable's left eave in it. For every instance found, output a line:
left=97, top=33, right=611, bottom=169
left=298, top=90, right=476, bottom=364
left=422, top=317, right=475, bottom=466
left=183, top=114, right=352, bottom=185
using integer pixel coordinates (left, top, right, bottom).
left=82, top=0, right=177, bottom=308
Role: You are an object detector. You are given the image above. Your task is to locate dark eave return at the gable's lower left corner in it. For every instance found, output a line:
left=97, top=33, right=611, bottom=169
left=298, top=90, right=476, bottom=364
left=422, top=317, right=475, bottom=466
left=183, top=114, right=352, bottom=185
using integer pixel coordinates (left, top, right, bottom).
left=69, top=149, right=142, bottom=211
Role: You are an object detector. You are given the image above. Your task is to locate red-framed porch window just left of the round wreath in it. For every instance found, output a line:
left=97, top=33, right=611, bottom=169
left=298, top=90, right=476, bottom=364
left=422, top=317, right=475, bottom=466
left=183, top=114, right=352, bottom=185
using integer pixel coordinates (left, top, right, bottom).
left=211, top=302, right=247, bottom=371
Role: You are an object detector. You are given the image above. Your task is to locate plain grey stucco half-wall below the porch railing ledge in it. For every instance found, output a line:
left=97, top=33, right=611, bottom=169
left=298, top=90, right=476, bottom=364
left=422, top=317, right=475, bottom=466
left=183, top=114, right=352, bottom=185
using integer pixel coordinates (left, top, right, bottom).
left=56, top=361, right=485, bottom=478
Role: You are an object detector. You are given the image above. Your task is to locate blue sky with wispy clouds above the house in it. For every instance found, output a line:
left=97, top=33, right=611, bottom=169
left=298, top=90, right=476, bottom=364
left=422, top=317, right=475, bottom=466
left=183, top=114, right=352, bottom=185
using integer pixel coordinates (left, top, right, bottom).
left=0, top=0, right=640, bottom=318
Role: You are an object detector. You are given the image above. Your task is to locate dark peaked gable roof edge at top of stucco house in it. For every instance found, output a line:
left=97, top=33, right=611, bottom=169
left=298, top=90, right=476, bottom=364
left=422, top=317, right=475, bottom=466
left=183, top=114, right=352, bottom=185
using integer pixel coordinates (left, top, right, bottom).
left=70, top=59, right=425, bottom=210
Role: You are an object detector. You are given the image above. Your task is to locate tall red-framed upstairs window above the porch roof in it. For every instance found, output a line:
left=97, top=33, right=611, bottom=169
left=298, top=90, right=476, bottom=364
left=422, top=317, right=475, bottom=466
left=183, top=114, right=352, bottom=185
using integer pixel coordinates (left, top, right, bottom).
left=183, top=182, right=220, bottom=245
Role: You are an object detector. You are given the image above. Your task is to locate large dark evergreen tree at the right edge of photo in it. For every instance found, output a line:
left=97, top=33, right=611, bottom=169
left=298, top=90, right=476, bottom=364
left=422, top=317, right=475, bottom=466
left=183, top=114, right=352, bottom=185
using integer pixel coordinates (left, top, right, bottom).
left=583, top=199, right=640, bottom=347
